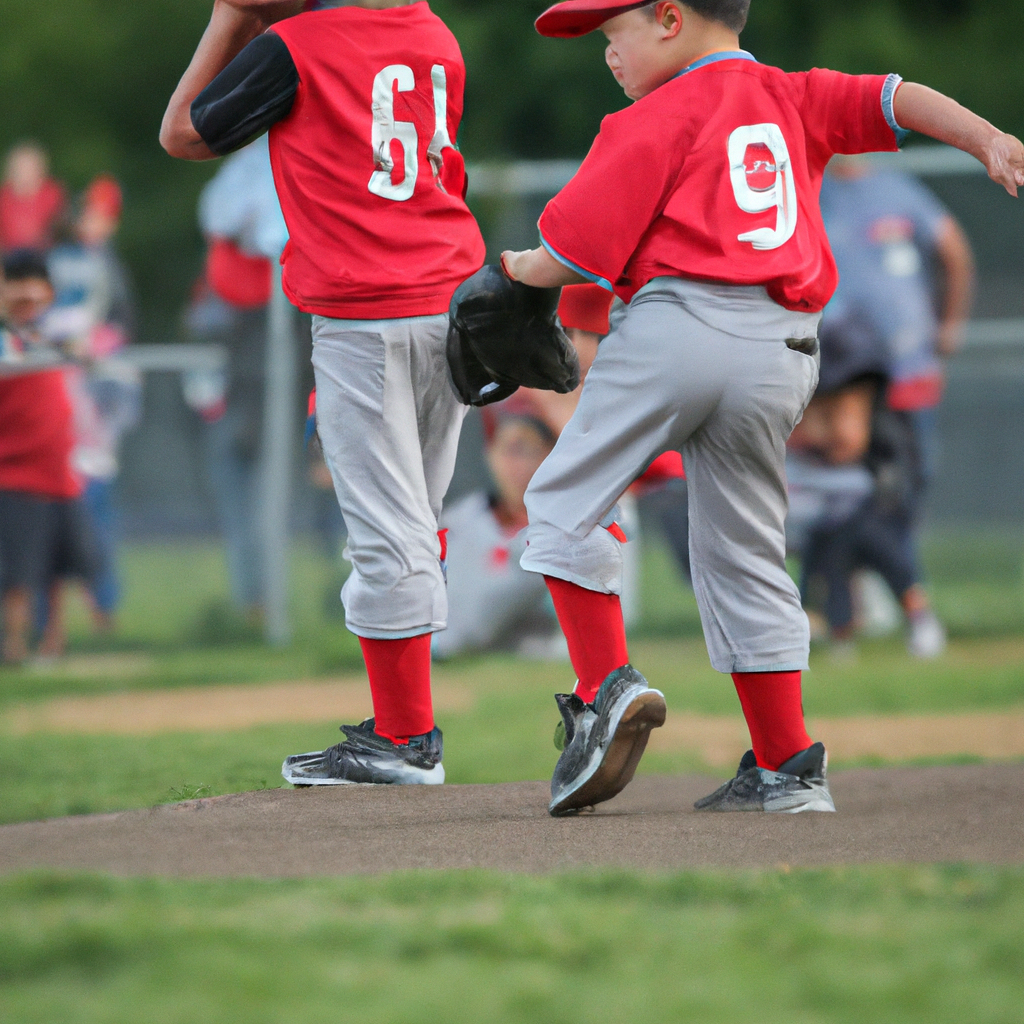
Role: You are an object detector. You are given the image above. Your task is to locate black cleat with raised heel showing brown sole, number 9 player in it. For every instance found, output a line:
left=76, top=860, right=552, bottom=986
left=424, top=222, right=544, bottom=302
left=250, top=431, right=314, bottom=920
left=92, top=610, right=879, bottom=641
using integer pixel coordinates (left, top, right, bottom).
left=548, top=665, right=666, bottom=817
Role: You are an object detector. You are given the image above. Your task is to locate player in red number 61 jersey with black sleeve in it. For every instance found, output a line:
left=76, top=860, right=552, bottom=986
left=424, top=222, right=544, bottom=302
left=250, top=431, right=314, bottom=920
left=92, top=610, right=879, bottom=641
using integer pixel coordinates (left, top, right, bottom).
left=161, top=0, right=484, bottom=785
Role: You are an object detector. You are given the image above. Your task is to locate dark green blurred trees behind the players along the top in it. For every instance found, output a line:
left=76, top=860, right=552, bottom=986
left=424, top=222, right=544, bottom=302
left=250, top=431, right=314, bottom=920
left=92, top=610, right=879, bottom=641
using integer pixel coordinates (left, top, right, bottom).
left=0, top=0, right=1024, bottom=340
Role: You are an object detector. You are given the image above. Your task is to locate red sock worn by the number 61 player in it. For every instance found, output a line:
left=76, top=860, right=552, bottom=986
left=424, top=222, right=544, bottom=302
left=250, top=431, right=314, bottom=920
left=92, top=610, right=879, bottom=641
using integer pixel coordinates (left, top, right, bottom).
left=359, top=633, right=434, bottom=743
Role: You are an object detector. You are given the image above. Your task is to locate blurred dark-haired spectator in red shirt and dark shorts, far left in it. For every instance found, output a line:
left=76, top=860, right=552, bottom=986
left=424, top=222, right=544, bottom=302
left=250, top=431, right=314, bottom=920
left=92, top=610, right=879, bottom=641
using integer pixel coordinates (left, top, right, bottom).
left=0, top=250, right=92, bottom=664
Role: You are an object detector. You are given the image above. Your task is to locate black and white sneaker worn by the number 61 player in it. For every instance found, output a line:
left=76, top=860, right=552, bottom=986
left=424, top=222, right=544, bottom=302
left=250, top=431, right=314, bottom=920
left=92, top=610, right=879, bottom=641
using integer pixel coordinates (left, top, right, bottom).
left=281, top=718, right=444, bottom=786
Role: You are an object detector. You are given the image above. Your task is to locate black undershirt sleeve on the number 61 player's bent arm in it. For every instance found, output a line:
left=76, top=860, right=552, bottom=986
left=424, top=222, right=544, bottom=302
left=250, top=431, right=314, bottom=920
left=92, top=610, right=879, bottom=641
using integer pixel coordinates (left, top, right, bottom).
left=190, top=32, right=299, bottom=157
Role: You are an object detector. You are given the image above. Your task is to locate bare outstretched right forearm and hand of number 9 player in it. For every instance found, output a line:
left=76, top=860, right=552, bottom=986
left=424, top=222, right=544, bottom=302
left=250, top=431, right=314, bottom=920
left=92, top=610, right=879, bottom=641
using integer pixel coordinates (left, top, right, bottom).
left=893, top=82, right=1024, bottom=197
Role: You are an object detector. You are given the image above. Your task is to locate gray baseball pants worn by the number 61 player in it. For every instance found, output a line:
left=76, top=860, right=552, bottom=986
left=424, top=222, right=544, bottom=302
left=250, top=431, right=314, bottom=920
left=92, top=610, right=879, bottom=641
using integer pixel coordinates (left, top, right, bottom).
left=312, top=313, right=466, bottom=640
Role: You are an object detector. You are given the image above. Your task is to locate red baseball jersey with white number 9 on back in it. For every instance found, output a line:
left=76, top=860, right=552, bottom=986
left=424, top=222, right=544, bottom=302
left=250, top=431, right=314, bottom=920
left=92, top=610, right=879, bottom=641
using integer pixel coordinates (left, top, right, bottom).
left=540, top=51, right=900, bottom=312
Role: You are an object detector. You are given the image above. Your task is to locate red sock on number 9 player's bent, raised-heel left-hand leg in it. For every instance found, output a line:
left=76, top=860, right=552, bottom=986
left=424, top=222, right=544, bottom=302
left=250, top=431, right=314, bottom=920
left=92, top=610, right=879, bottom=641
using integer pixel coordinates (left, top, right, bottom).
left=544, top=577, right=630, bottom=703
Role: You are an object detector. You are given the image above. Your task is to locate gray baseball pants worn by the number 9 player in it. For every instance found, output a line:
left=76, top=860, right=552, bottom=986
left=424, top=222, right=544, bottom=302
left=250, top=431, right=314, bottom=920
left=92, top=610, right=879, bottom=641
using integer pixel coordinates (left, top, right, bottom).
left=521, top=278, right=820, bottom=672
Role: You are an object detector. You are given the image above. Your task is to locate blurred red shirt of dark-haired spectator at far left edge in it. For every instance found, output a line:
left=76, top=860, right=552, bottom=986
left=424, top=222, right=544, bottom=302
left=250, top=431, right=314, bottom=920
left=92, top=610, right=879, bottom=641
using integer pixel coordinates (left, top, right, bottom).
left=0, top=370, right=82, bottom=500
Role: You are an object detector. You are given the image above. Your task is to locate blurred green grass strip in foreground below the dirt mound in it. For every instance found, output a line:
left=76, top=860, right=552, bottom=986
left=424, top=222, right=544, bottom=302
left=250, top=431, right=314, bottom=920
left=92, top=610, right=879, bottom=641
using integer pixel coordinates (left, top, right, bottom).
left=0, top=867, right=1024, bottom=1024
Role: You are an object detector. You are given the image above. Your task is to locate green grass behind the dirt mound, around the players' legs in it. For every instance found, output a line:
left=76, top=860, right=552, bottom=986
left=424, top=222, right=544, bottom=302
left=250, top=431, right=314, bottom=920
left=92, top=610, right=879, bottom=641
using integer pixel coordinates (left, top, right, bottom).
left=0, top=534, right=1024, bottom=822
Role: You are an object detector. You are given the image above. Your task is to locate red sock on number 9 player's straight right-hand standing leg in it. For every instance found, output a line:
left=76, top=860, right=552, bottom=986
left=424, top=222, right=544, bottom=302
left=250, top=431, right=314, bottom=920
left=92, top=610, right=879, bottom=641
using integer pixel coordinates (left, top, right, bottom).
left=732, top=672, right=811, bottom=771
